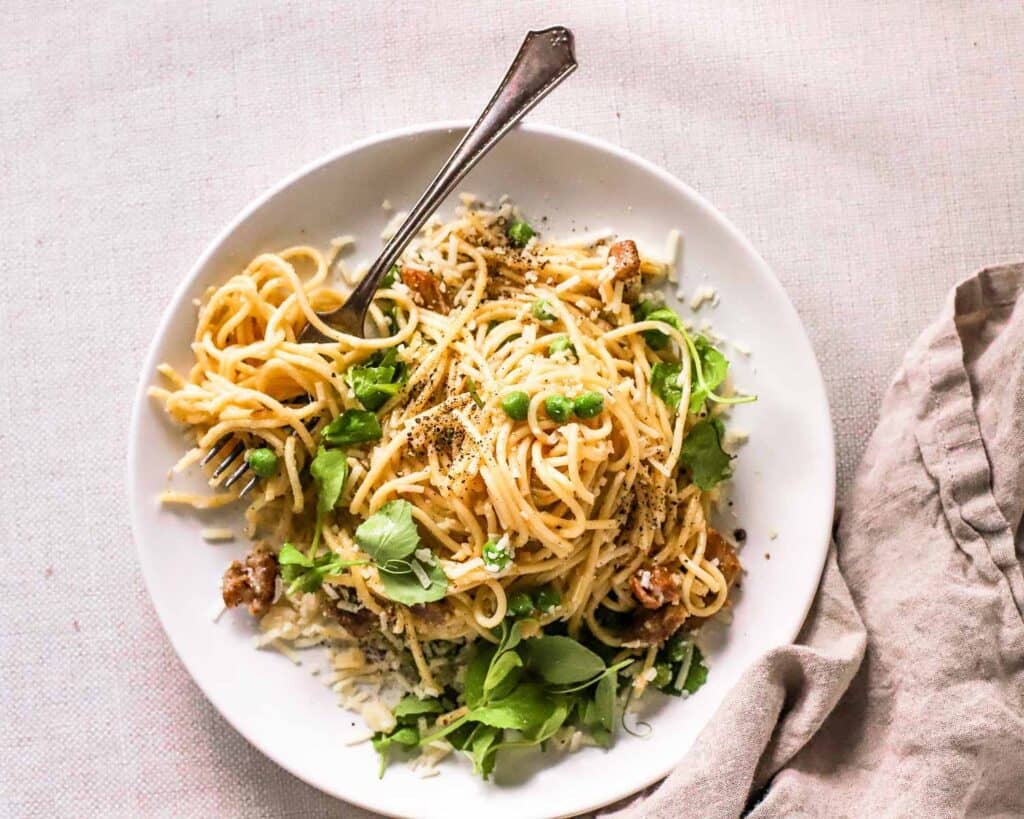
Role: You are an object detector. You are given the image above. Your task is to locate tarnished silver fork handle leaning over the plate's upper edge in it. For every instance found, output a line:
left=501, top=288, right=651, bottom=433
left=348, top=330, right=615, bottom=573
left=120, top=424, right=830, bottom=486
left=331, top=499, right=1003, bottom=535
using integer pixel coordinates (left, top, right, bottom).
left=339, top=26, right=577, bottom=336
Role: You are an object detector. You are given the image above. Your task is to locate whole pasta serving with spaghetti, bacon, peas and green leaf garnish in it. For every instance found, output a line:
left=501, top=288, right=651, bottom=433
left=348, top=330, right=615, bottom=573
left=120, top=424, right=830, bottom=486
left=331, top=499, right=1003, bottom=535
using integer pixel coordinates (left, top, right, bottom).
left=151, top=198, right=745, bottom=775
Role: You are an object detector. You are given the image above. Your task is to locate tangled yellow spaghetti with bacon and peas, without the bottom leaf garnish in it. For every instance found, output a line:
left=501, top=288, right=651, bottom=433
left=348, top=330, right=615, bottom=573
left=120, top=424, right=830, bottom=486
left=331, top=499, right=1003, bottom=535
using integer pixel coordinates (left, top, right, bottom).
left=152, top=198, right=739, bottom=769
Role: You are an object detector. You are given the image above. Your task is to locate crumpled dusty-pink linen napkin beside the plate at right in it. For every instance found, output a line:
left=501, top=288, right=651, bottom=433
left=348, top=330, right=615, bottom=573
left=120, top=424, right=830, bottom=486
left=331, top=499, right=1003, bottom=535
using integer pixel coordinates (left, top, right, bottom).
left=612, top=264, right=1024, bottom=819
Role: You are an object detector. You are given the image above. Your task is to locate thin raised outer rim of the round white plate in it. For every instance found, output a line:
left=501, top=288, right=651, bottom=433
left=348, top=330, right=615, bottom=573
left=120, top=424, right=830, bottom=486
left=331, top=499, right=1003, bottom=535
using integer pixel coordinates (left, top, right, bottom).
left=125, top=120, right=836, bottom=817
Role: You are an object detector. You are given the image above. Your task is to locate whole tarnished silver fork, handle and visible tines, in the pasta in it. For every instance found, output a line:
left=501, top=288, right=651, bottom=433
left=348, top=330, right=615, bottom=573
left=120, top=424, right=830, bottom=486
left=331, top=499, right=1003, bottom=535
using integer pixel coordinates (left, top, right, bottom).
left=200, top=26, right=577, bottom=498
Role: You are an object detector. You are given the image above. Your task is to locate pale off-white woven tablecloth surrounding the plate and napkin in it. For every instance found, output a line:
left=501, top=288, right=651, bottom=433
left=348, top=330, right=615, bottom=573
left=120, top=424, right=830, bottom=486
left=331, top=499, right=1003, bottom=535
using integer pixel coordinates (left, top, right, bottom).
left=0, top=0, right=1024, bottom=817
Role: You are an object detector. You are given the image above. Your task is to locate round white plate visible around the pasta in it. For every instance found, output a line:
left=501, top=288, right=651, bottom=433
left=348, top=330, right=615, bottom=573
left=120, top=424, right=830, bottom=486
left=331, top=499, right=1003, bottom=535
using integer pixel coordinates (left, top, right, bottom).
left=128, top=124, right=835, bottom=819
